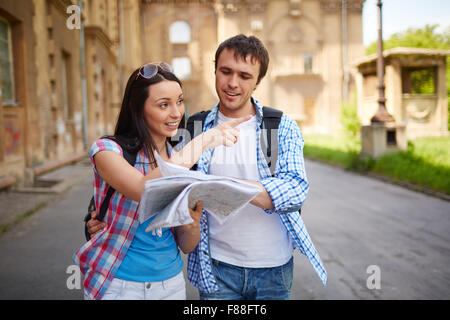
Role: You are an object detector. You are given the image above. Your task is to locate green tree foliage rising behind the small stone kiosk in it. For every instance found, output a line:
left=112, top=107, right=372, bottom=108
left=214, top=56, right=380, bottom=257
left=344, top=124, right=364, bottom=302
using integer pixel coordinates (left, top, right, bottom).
left=366, top=24, right=450, bottom=130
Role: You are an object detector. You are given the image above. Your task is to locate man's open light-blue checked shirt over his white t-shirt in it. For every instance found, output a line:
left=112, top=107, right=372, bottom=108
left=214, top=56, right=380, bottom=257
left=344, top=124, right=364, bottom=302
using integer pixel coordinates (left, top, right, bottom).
left=187, top=99, right=327, bottom=293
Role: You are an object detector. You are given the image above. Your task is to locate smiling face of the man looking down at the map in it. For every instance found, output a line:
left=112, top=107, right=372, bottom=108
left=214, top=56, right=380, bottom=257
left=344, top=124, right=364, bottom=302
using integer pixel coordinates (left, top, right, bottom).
left=216, top=49, right=260, bottom=118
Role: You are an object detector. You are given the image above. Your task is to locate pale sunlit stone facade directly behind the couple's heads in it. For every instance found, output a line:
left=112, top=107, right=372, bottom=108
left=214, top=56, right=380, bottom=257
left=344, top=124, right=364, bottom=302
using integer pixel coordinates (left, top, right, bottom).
left=141, top=0, right=364, bottom=133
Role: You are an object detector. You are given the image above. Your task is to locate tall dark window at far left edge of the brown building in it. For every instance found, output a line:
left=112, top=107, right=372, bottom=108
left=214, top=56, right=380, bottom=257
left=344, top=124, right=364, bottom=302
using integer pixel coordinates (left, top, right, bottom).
left=0, top=18, right=15, bottom=104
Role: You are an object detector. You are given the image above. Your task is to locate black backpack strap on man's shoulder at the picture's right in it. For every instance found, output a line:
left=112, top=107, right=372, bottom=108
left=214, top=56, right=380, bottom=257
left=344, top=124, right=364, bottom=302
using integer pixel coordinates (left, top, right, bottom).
left=260, top=107, right=283, bottom=176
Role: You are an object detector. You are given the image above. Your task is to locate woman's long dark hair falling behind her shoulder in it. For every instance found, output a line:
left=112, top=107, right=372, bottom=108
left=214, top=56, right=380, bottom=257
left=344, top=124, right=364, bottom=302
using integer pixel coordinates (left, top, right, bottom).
left=106, top=67, right=185, bottom=168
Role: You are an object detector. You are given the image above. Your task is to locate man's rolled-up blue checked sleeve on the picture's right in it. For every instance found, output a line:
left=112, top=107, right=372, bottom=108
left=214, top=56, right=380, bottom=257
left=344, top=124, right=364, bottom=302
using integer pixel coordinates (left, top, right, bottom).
left=260, top=115, right=309, bottom=213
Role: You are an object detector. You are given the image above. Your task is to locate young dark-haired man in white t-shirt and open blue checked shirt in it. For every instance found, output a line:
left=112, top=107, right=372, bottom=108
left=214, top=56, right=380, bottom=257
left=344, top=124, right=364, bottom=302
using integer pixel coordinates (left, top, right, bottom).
left=88, top=35, right=327, bottom=300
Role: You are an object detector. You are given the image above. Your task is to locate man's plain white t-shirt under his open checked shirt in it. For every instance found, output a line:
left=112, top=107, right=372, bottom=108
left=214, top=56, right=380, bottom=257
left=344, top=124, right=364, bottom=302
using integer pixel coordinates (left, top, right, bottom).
left=208, top=112, right=293, bottom=268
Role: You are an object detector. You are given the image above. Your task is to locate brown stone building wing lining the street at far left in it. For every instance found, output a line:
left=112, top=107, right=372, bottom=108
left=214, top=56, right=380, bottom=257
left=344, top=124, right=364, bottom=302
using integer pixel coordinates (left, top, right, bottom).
left=0, top=0, right=121, bottom=187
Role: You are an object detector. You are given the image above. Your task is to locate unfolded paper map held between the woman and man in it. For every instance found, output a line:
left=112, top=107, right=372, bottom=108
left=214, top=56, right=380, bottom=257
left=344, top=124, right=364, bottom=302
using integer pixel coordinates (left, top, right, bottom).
left=138, top=153, right=261, bottom=232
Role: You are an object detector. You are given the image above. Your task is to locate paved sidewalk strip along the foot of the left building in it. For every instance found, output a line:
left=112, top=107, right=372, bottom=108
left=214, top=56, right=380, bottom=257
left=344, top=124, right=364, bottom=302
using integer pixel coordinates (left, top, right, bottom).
left=0, top=157, right=92, bottom=234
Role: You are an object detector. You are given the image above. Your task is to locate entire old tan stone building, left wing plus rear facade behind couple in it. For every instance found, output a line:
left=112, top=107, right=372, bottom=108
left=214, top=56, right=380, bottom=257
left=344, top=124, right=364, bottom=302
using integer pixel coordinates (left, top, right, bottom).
left=0, top=0, right=364, bottom=187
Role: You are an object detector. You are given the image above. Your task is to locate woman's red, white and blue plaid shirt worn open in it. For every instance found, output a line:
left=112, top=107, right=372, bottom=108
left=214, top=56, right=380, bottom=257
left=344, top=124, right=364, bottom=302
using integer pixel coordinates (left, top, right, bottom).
left=73, top=139, right=149, bottom=299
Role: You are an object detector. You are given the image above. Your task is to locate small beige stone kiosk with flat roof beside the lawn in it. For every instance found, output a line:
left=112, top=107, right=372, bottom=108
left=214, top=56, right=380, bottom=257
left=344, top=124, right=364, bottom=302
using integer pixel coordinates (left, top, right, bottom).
left=356, top=47, right=450, bottom=158
